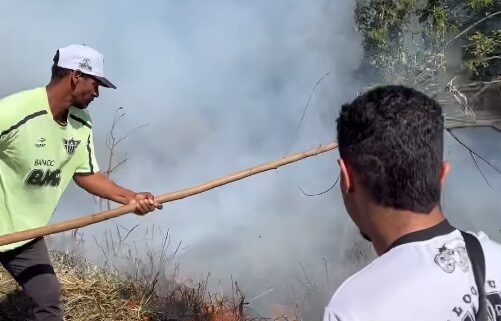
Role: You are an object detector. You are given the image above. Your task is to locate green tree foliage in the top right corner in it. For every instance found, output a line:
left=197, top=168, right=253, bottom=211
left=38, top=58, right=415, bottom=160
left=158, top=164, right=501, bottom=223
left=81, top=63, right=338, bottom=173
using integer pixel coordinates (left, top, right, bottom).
left=355, top=0, right=501, bottom=84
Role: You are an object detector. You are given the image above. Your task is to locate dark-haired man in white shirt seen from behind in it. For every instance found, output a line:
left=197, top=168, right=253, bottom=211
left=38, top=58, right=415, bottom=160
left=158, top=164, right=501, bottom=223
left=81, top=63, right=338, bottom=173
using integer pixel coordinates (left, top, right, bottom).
left=324, top=86, right=501, bottom=321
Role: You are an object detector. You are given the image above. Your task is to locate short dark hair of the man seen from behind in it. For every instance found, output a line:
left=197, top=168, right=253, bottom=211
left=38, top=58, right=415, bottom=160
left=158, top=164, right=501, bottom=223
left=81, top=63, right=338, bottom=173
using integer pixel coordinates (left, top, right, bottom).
left=337, top=86, right=444, bottom=213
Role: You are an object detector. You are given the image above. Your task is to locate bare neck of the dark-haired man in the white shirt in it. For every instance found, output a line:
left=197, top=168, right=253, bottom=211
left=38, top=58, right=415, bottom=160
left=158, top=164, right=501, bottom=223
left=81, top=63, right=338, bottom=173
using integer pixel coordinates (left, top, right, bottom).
left=370, top=206, right=445, bottom=255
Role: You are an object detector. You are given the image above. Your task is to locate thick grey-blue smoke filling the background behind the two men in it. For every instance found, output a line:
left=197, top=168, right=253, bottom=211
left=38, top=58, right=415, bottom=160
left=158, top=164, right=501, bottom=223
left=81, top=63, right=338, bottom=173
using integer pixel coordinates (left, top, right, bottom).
left=0, top=0, right=501, bottom=316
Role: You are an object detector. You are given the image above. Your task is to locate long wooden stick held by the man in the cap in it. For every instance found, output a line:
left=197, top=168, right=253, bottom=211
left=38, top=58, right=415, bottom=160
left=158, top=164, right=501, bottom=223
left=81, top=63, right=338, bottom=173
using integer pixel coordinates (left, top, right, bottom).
left=0, top=142, right=337, bottom=245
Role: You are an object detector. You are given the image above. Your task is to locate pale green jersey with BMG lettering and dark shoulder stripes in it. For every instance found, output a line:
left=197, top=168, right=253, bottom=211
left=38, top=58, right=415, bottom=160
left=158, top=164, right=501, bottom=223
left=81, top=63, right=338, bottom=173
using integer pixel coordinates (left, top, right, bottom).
left=0, top=87, right=99, bottom=252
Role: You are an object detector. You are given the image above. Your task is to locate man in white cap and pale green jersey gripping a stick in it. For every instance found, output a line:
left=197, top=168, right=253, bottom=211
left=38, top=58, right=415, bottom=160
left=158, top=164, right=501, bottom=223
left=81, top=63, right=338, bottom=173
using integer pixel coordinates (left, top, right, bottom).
left=0, top=45, right=162, bottom=321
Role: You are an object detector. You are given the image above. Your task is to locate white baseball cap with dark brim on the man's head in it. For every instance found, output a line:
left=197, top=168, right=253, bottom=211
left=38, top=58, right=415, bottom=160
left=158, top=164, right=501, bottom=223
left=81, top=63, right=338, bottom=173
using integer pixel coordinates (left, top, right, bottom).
left=54, top=45, right=117, bottom=89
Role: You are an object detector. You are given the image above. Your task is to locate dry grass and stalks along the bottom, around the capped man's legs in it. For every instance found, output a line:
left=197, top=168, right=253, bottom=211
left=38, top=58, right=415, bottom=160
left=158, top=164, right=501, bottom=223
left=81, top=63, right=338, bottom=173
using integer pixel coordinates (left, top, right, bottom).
left=0, top=222, right=312, bottom=321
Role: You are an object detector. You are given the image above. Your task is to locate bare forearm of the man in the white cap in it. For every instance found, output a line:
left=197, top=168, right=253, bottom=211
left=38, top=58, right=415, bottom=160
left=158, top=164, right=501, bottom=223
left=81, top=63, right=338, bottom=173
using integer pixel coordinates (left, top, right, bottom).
left=75, top=173, right=135, bottom=204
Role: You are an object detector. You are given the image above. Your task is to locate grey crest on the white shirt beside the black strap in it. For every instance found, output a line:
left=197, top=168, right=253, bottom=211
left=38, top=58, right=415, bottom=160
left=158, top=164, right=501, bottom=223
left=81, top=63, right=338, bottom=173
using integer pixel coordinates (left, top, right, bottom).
left=435, top=239, right=470, bottom=273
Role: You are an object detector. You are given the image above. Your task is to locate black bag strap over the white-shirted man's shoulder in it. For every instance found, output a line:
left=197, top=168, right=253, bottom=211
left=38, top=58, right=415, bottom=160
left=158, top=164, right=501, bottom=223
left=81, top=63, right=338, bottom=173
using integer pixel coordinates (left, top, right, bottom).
left=461, top=231, right=489, bottom=321
